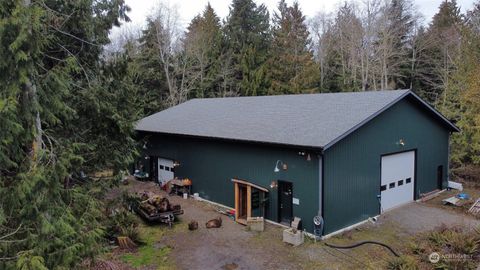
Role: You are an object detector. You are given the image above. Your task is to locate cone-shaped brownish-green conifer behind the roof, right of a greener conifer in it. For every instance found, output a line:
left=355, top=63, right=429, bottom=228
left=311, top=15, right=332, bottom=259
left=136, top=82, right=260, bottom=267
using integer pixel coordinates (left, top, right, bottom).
left=269, top=0, right=320, bottom=94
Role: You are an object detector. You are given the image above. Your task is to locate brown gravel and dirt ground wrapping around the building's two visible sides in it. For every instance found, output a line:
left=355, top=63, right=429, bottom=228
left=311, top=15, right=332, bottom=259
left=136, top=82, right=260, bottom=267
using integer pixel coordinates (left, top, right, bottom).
left=113, top=180, right=480, bottom=270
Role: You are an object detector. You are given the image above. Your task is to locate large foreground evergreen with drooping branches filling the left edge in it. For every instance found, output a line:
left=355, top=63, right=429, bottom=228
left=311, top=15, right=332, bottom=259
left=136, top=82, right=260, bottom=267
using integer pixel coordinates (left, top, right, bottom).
left=0, top=0, right=131, bottom=269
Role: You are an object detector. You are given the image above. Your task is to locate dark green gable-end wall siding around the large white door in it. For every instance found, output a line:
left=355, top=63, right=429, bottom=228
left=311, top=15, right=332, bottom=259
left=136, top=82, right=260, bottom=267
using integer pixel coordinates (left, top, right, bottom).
left=323, top=98, right=449, bottom=234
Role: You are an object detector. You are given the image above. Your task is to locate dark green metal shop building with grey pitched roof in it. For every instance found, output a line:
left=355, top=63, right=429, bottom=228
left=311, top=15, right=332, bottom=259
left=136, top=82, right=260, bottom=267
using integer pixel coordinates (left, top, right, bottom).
left=136, top=90, right=459, bottom=235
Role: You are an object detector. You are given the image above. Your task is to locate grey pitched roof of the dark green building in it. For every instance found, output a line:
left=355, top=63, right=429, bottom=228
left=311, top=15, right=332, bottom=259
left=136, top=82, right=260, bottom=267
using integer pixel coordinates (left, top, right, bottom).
left=136, top=90, right=456, bottom=148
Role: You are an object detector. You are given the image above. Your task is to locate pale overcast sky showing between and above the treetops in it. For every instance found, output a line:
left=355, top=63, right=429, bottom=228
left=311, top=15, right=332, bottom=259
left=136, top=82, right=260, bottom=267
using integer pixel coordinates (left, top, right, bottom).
left=109, top=0, right=474, bottom=37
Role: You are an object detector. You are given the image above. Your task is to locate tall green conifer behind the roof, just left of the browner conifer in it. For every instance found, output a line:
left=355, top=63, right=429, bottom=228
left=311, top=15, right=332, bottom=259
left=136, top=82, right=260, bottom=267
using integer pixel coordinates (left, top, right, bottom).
left=224, top=0, right=271, bottom=96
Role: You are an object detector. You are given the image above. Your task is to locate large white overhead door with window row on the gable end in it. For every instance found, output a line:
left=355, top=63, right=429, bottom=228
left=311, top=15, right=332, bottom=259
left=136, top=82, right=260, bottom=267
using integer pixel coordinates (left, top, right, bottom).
left=380, top=151, right=415, bottom=212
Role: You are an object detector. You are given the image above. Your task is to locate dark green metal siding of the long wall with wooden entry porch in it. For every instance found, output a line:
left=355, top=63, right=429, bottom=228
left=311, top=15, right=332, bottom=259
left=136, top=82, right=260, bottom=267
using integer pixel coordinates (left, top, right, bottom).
left=146, top=134, right=319, bottom=232
